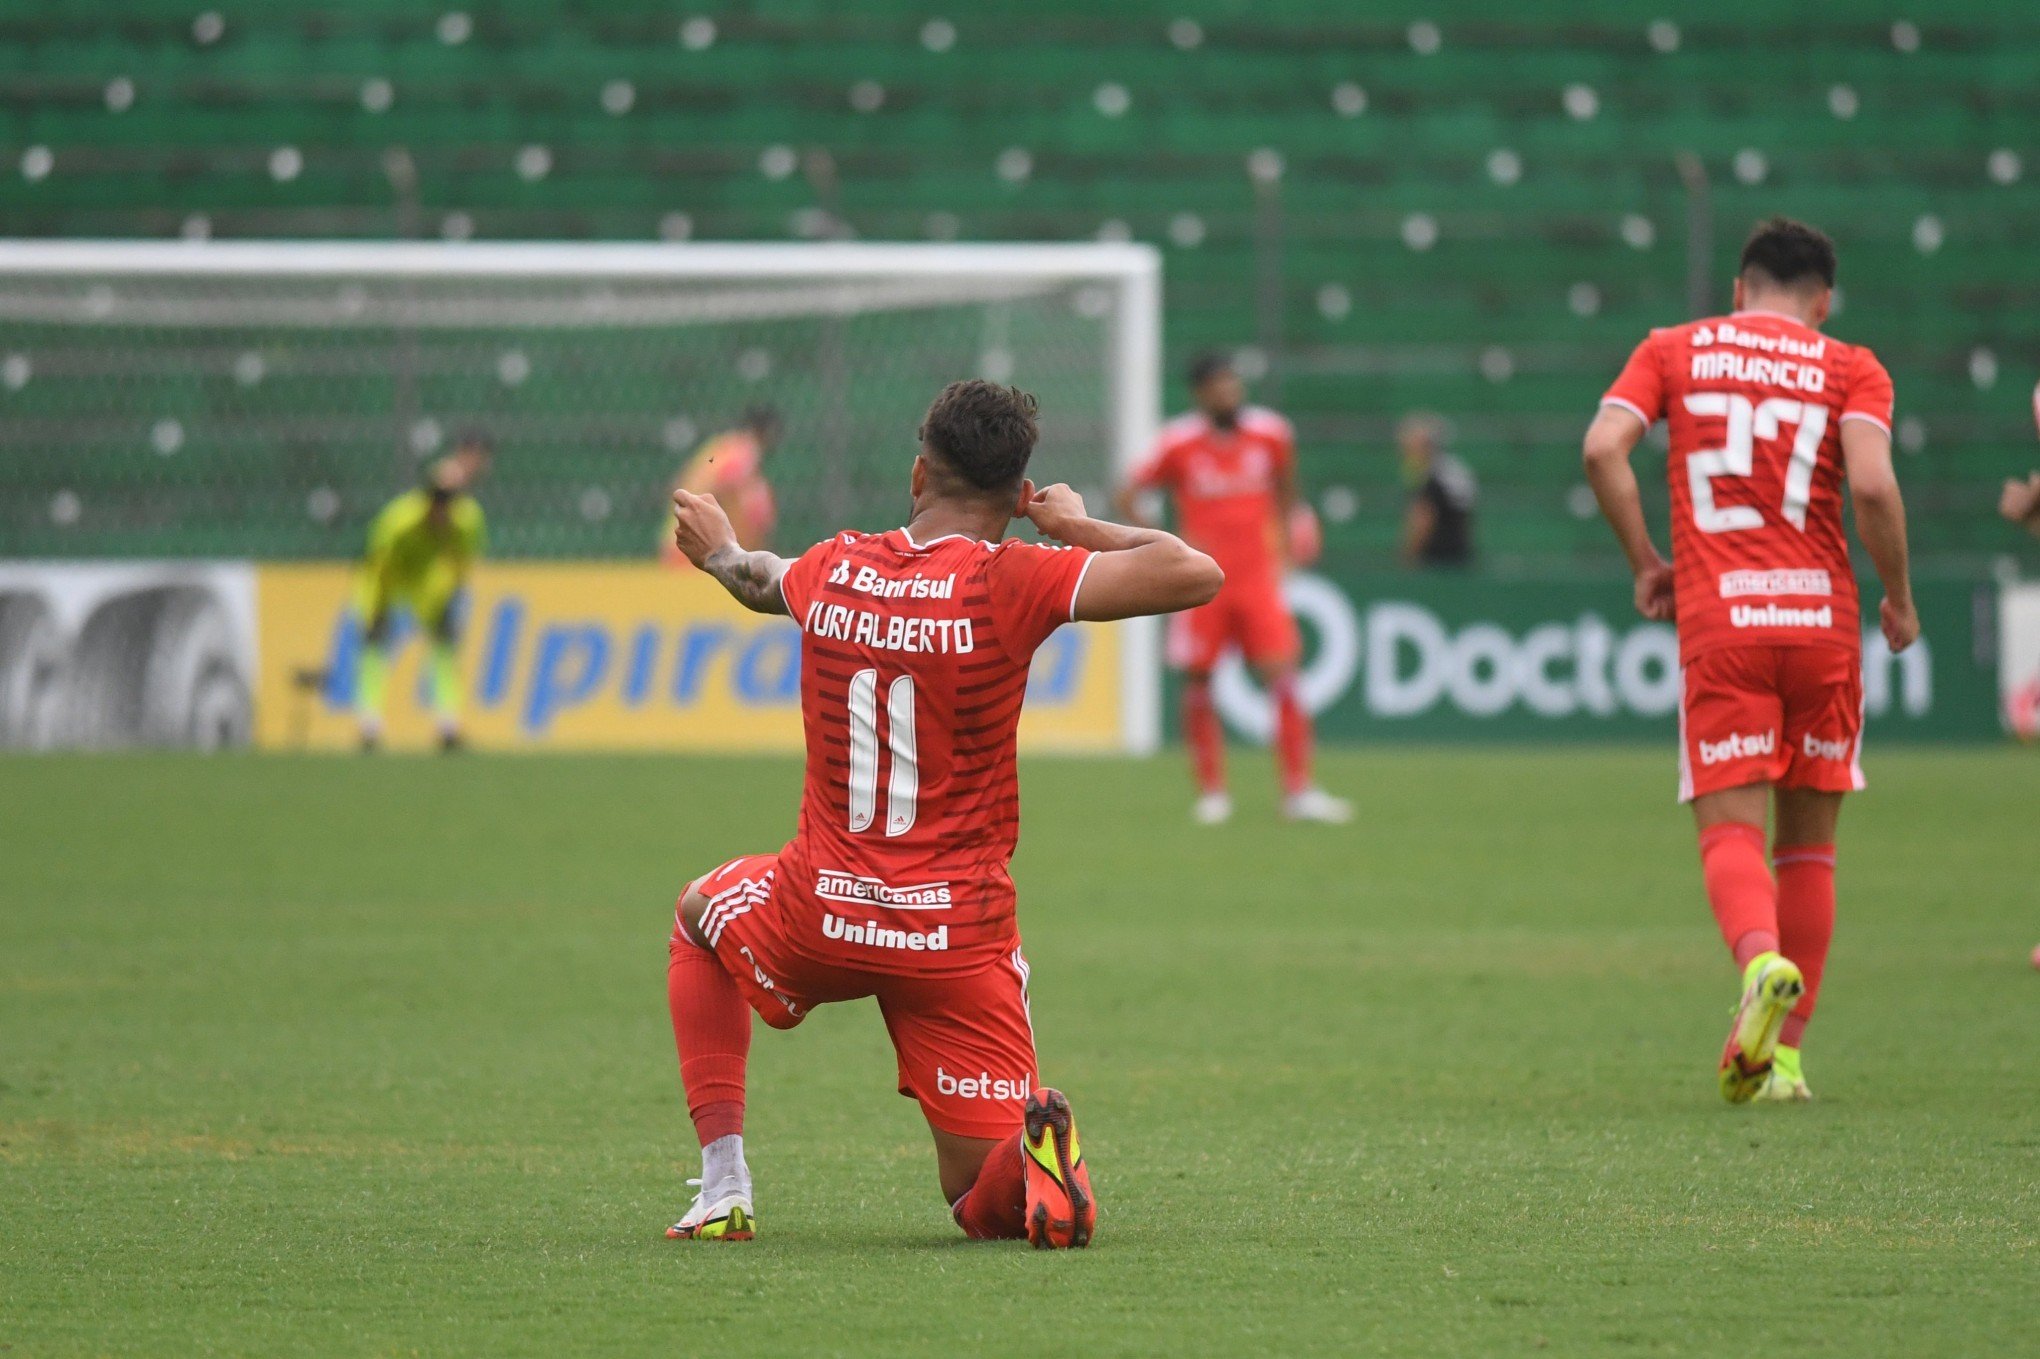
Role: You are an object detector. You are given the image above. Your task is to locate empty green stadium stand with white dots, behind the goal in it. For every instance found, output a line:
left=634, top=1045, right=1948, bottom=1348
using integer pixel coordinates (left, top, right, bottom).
left=0, top=0, right=2040, bottom=567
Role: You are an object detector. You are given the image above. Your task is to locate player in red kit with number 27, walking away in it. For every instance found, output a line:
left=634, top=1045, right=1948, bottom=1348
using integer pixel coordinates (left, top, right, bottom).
left=1585, top=218, right=1920, bottom=1104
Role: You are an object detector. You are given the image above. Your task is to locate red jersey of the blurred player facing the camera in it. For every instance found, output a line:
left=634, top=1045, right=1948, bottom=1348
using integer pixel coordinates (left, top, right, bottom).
left=1134, top=406, right=1295, bottom=582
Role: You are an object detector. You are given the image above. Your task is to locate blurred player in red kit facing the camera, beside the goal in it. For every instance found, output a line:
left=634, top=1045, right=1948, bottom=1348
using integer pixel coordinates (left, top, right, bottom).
left=1118, top=355, right=1353, bottom=826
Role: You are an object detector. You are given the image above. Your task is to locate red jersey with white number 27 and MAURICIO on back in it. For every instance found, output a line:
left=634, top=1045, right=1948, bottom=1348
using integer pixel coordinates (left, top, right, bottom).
left=1601, top=312, right=1891, bottom=659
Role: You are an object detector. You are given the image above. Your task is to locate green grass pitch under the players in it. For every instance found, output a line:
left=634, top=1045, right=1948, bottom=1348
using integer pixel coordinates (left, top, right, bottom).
left=0, top=749, right=2040, bottom=1357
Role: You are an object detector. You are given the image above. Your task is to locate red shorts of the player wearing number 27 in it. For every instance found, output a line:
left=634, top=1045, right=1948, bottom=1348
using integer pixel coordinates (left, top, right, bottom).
left=1679, top=647, right=1863, bottom=802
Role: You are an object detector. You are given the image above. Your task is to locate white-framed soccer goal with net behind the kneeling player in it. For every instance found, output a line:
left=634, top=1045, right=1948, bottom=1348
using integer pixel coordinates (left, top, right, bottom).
left=0, top=241, right=1159, bottom=749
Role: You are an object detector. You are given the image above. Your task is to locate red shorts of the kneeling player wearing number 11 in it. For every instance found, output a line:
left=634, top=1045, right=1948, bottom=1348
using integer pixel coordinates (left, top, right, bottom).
left=671, top=855, right=1034, bottom=1137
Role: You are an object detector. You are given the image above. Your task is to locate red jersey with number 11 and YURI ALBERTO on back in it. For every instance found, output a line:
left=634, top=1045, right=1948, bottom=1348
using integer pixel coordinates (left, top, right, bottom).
left=779, top=529, right=1091, bottom=975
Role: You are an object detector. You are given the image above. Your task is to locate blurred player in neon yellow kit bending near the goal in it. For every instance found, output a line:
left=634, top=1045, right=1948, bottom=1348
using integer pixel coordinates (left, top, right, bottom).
left=355, top=435, right=492, bottom=751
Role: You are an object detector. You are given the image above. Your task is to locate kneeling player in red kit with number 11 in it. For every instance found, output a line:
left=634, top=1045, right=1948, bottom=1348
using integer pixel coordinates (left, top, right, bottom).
left=667, top=382, right=1224, bottom=1247
